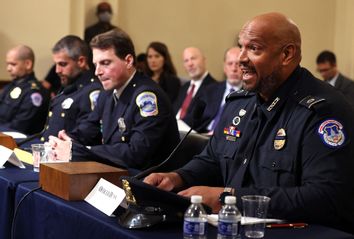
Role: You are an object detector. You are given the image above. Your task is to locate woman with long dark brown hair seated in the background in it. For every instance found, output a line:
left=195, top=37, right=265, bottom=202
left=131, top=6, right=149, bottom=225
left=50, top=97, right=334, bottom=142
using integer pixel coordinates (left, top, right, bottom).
left=146, top=42, right=181, bottom=103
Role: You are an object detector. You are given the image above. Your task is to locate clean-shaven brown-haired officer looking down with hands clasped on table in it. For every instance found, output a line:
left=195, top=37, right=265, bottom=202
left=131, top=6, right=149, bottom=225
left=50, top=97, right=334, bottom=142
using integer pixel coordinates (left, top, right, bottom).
left=50, top=30, right=179, bottom=170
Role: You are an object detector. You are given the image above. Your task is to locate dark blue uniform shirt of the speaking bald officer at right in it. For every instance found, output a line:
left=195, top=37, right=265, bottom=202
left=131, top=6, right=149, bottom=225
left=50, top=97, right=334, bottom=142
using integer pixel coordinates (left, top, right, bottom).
left=177, top=67, right=354, bottom=232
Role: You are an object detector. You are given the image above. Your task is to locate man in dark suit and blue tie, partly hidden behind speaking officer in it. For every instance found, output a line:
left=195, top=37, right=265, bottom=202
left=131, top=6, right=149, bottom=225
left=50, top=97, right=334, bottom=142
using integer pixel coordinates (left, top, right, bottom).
left=195, top=47, right=242, bottom=135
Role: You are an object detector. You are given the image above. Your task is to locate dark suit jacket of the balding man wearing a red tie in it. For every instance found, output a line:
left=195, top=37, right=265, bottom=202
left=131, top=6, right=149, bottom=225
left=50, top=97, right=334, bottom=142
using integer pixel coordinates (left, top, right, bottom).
left=173, top=74, right=216, bottom=126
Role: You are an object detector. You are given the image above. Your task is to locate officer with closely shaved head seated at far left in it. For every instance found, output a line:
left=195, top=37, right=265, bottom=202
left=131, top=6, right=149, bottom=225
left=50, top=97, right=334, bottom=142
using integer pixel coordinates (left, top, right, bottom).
left=0, top=45, right=49, bottom=134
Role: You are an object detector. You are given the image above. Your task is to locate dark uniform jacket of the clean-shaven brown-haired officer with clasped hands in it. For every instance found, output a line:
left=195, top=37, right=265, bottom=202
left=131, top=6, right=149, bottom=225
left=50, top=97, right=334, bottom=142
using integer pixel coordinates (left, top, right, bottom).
left=71, top=73, right=179, bottom=170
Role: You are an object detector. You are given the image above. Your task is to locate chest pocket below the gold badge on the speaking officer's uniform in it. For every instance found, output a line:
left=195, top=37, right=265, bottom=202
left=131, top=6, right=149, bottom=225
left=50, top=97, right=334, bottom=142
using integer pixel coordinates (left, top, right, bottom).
left=260, top=150, right=296, bottom=187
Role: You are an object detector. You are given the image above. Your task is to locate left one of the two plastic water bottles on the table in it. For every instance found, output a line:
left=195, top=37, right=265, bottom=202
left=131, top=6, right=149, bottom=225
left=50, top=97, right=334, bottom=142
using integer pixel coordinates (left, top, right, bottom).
left=183, top=195, right=207, bottom=239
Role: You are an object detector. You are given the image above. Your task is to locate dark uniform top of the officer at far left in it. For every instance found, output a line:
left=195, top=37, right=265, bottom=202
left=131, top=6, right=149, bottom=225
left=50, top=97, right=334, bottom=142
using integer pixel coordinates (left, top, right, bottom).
left=0, top=73, right=49, bottom=134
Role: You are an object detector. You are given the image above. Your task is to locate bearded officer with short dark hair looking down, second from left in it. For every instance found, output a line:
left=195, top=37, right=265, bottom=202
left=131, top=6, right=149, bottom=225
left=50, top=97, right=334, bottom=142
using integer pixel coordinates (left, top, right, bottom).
left=41, top=35, right=102, bottom=142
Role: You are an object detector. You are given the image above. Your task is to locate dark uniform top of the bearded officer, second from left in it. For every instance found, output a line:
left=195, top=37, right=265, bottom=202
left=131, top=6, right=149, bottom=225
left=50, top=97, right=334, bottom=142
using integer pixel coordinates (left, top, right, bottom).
left=41, top=71, right=102, bottom=142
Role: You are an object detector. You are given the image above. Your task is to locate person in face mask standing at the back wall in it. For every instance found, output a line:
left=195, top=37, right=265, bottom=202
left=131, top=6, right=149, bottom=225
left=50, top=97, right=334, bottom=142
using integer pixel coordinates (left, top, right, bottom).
left=84, top=2, right=118, bottom=44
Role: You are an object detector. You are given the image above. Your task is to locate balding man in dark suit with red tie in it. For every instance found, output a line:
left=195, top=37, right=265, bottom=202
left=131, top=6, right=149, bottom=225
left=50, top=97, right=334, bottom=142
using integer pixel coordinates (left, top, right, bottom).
left=174, top=47, right=216, bottom=130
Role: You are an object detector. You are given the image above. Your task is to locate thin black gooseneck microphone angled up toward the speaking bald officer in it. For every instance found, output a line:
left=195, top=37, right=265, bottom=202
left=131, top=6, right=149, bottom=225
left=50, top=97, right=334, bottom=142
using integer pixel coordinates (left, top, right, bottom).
left=133, top=99, right=206, bottom=179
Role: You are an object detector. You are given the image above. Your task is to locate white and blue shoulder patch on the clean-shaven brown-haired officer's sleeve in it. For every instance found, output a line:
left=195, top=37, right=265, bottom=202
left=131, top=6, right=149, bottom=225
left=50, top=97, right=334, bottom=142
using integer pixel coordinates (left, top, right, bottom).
left=136, top=91, right=159, bottom=117
